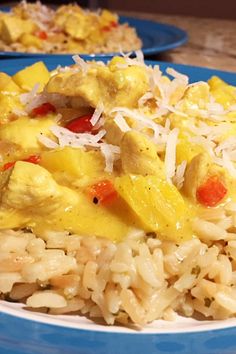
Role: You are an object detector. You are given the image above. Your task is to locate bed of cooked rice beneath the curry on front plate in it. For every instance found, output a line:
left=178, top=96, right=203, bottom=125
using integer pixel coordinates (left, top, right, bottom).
left=0, top=203, right=236, bottom=326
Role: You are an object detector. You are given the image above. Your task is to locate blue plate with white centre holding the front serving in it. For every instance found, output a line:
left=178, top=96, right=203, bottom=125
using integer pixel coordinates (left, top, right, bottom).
left=0, top=57, right=236, bottom=354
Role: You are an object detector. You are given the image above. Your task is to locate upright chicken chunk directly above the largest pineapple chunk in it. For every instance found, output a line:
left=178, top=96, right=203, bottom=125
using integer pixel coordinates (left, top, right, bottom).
left=120, top=131, right=165, bottom=178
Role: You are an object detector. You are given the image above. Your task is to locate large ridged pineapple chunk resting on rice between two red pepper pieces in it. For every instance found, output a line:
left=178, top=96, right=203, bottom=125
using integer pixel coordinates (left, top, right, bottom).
left=115, top=175, right=192, bottom=242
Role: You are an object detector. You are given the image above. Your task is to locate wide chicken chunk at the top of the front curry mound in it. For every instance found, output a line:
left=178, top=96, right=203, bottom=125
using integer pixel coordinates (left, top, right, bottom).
left=46, top=59, right=148, bottom=112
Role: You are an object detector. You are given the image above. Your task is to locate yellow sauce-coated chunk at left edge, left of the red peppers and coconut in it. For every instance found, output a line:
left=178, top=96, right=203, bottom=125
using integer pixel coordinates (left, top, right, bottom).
left=0, top=117, right=55, bottom=150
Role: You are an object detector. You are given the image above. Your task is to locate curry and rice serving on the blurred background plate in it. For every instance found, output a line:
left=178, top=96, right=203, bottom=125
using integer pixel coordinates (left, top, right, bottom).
left=0, top=0, right=142, bottom=54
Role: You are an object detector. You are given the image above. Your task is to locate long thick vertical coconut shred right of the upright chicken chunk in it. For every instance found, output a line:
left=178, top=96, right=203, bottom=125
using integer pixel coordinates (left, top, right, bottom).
left=165, top=128, right=179, bottom=182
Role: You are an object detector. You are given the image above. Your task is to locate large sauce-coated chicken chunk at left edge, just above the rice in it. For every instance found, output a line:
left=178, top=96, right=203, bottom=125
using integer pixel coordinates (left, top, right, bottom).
left=2, top=161, right=77, bottom=214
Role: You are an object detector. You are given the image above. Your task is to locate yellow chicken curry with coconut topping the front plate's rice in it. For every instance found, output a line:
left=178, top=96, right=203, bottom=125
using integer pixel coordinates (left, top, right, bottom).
left=0, top=54, right=236, bottom=243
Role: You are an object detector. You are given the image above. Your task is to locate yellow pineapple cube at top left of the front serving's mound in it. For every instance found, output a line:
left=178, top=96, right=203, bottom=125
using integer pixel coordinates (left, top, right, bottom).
left=12, top=61, right=50, bottom=91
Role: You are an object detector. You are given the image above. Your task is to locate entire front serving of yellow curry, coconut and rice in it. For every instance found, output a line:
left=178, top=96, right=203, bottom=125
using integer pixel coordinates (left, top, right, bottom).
left=0, top=52, right=236, bottom=326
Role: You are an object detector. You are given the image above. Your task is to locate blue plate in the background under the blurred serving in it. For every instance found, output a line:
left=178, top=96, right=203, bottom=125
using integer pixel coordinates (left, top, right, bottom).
left=0, top=7, right=188, bottom=59
